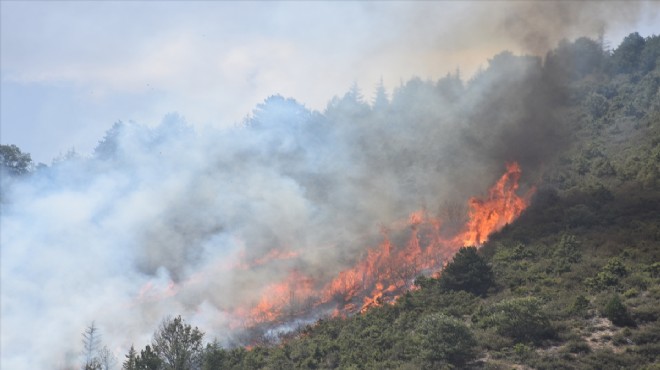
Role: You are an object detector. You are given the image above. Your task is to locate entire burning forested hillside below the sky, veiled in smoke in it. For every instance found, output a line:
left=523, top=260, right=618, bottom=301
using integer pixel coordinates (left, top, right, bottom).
left=0, top=33, right=660, bottom=370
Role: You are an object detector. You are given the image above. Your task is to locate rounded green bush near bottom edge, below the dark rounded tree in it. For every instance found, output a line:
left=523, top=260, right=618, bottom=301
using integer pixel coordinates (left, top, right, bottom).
left=415, top=314, right=477, bottom=368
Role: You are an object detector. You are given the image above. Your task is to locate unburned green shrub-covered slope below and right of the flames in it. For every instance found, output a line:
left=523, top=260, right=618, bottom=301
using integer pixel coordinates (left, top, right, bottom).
left=2, top=33, right=660, bottom=369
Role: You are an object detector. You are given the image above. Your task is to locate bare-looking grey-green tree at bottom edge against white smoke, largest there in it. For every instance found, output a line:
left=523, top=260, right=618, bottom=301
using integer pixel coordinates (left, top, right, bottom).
left=152, top=316, right=204, bottom=370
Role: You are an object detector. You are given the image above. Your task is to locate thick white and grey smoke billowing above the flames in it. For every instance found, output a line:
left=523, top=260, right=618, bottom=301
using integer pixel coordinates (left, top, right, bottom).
left=0, top=2, right=656, bottom=369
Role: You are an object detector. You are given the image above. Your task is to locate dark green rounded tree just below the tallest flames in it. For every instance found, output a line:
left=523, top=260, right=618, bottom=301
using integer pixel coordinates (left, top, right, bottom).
left=440, top=247, right=495, bottom=296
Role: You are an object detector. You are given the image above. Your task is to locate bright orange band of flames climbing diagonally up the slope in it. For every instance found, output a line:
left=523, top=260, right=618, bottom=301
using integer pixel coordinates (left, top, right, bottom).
left=234, top=163, right=534, bottom=326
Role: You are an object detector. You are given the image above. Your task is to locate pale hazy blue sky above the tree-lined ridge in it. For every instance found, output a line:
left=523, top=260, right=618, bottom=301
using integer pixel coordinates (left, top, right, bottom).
left=0, top=1, right=660, bottom=164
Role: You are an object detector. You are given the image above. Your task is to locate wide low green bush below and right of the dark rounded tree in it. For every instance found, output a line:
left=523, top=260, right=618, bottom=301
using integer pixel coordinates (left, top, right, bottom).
left=476, top=297, right=554, bottom=344
